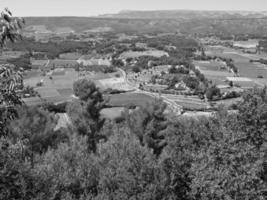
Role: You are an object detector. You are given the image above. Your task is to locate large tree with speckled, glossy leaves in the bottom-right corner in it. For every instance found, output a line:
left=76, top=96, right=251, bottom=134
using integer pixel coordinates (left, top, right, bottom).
left=190, top=123, right=267, bottom=200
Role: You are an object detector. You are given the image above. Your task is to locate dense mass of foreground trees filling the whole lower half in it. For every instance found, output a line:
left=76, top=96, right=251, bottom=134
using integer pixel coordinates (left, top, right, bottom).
left=0, top=74, right=267, bottom=200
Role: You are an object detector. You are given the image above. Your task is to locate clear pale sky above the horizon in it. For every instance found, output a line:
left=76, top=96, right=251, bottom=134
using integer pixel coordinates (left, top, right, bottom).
left=0, top=0, right=267, bottom=16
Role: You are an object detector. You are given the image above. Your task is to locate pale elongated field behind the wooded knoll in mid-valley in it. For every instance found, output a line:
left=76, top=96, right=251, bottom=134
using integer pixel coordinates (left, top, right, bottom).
left=120, top=50, right=169, bottom=59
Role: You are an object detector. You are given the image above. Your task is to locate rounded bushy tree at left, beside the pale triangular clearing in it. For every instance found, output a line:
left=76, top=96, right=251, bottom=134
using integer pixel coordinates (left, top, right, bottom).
left=9, top=107, right=60, bottom=167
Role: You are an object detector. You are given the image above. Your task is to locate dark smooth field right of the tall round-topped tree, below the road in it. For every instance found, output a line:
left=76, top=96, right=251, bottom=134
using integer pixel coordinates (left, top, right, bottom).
left=108, top=93, right=154, bottom=107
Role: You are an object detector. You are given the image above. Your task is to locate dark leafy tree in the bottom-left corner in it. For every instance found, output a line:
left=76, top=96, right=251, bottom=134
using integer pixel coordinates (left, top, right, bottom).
left=0, top=138, right=35, bottom=200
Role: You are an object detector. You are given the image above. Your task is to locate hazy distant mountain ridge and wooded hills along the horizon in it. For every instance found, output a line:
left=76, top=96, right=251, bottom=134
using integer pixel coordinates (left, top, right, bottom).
left=22, top=10, right=267, bottom=35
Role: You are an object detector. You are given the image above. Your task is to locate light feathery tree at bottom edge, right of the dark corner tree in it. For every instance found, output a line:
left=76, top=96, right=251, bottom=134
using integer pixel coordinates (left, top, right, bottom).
left=34, top=134, right=100, bottom=200
